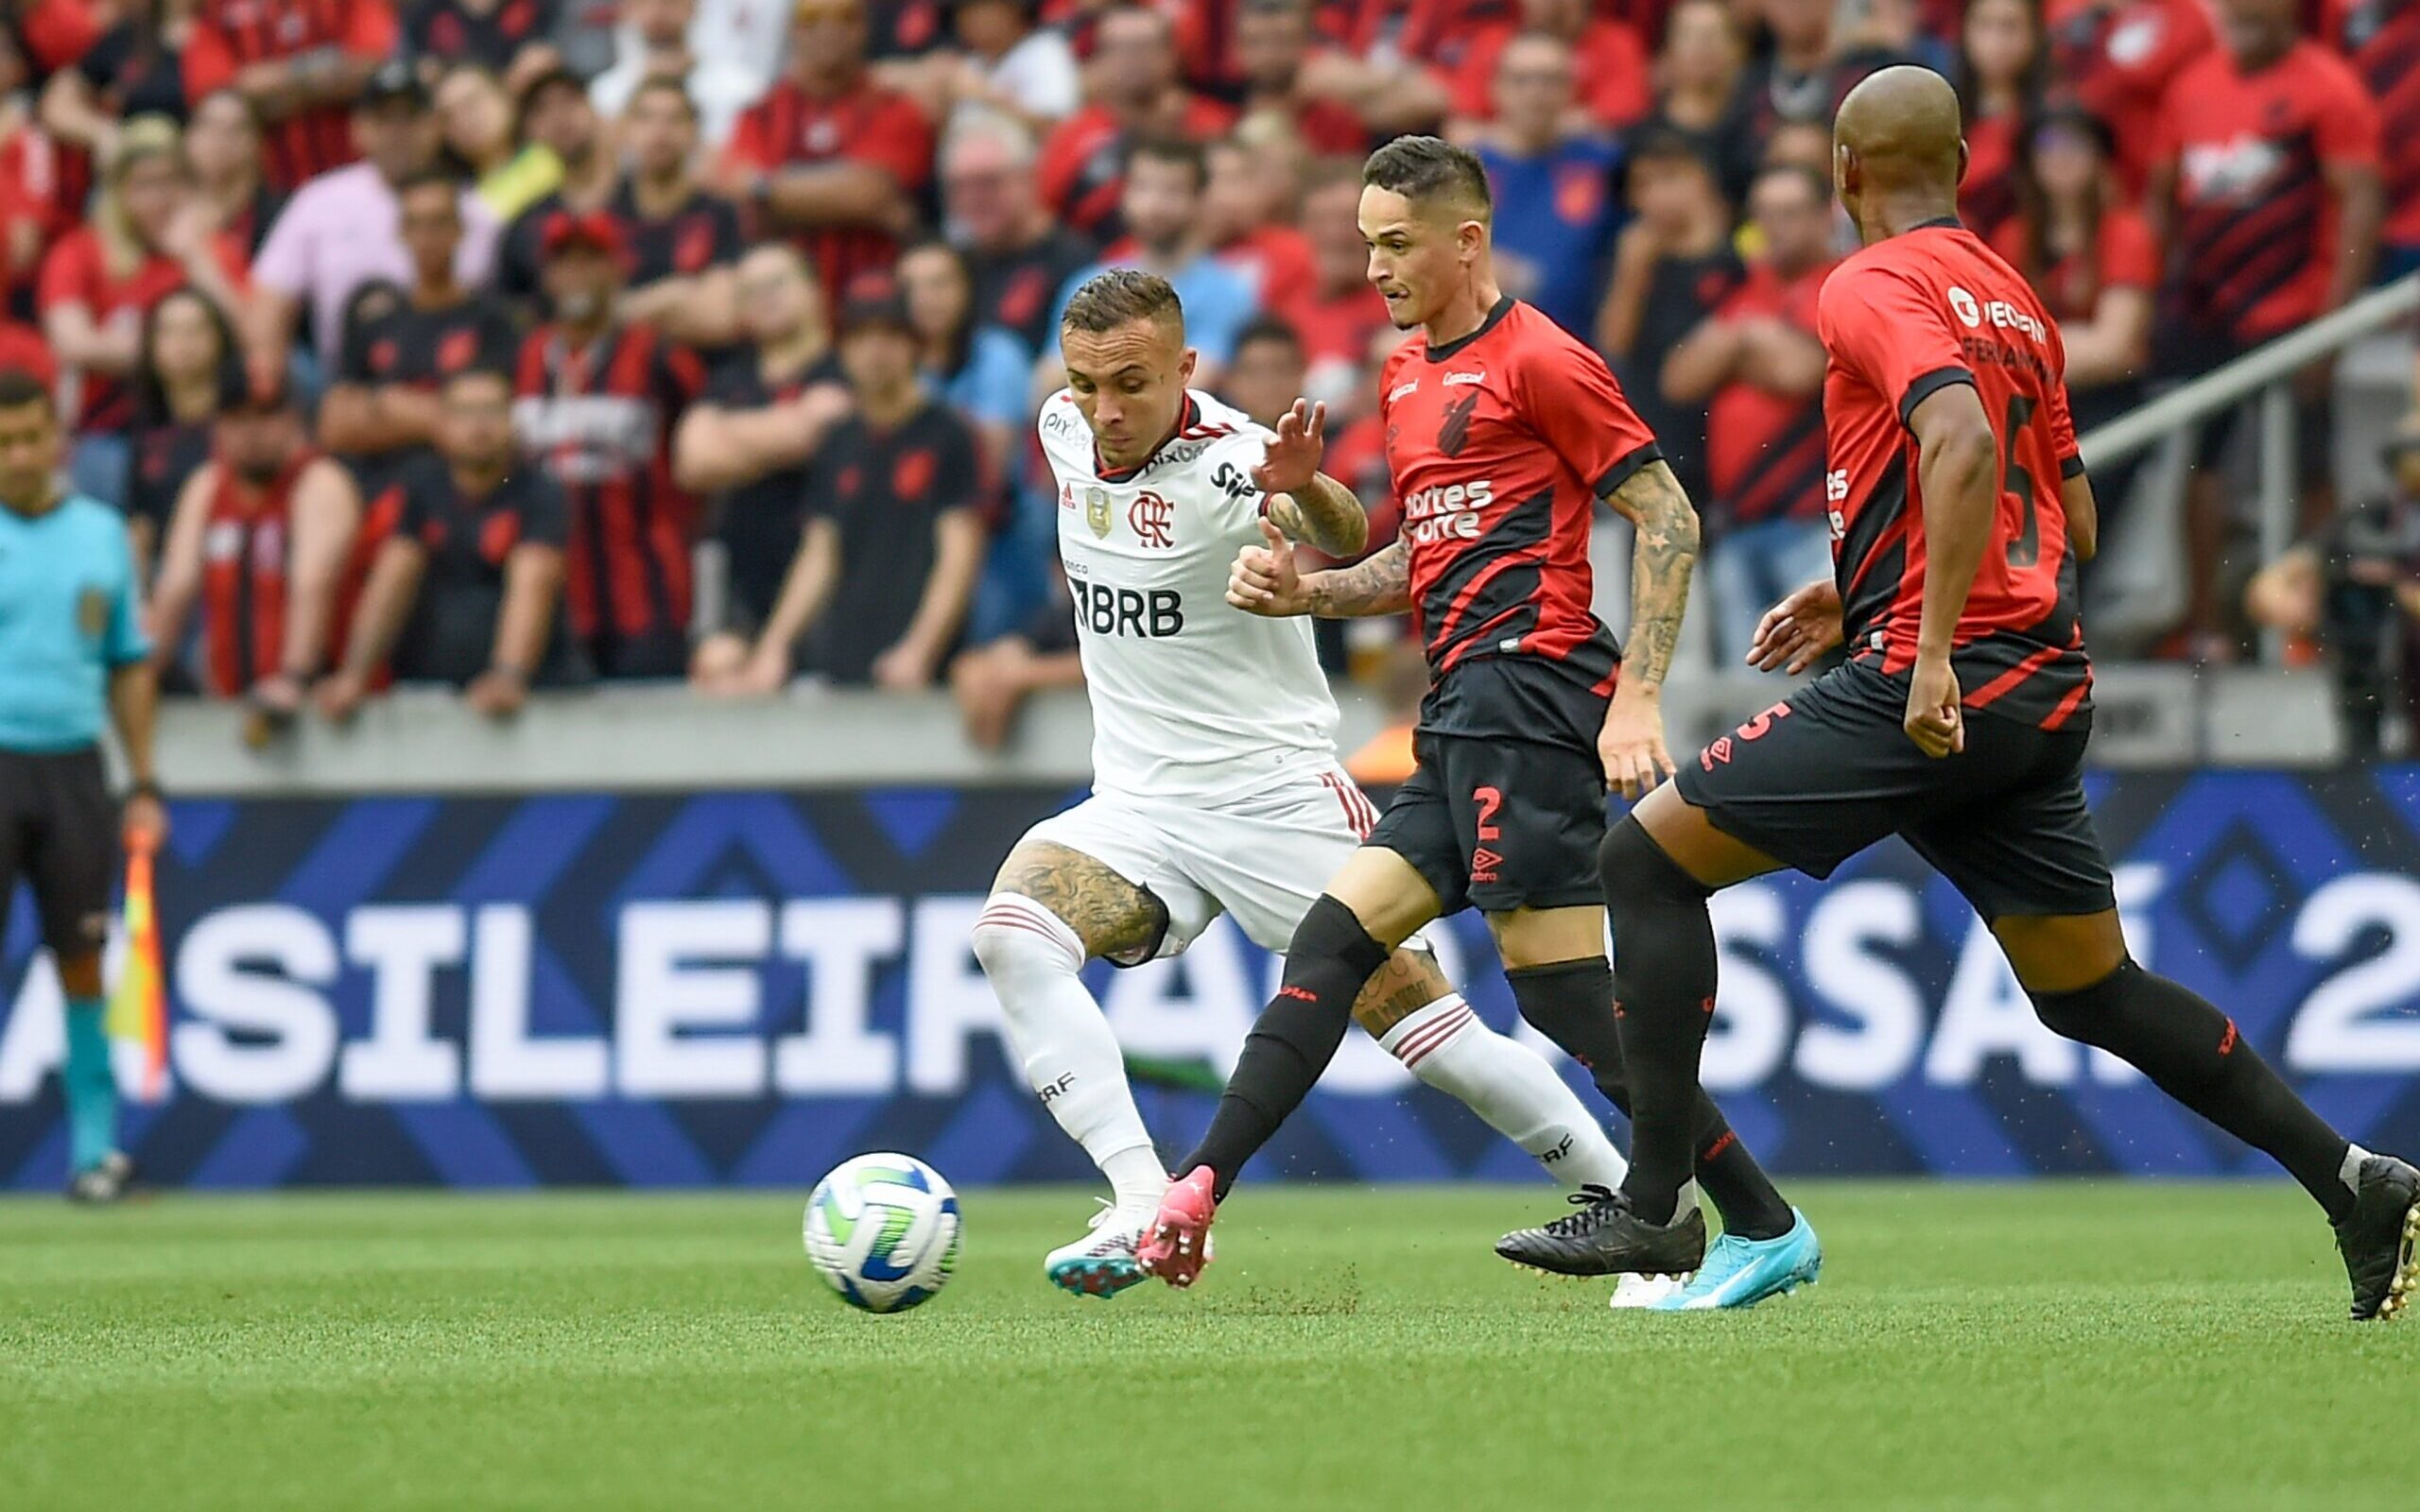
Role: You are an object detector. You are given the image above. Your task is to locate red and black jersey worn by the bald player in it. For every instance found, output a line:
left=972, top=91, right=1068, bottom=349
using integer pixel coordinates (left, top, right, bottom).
left=1818, top=220, right=2093, bottom=729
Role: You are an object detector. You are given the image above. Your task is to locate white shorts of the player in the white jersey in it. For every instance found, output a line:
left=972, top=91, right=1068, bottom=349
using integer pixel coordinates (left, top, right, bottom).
left=1026, top=767, right=1426, bottom=965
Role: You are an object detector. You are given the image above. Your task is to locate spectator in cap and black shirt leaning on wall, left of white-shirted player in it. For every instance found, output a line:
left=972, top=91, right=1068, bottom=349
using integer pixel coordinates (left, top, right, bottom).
left=709, top=273, right=982, bottom=695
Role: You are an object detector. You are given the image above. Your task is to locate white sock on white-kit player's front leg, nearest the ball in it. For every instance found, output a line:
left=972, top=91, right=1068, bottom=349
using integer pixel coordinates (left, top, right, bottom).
left=973, top=893, right=1168, bottom=1207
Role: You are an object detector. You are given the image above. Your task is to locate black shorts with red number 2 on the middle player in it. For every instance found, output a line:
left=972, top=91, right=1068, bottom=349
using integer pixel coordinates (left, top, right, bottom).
left=1365, top=730, right=1604, bottom=915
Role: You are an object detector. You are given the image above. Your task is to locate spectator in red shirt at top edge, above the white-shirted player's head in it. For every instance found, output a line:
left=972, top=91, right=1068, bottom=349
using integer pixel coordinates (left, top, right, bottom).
left=1038, top=5, right=1235, bottom=242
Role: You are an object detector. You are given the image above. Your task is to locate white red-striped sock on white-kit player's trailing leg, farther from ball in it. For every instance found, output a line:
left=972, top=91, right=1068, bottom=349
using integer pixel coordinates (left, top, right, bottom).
left=1379, top=992, right=1631, bottom=1188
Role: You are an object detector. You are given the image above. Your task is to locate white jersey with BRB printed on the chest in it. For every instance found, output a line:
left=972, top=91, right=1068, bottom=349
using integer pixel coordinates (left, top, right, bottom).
left=1038, top=389, right=1336, bottom=800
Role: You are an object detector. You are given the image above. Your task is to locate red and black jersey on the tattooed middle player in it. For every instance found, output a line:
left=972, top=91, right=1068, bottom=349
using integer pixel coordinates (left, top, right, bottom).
left=1379, top=295, right=1660, bottom=733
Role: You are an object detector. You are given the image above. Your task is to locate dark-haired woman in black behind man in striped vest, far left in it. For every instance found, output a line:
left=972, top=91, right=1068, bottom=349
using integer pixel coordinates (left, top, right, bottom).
left=126, top=288, right=245, bottom=583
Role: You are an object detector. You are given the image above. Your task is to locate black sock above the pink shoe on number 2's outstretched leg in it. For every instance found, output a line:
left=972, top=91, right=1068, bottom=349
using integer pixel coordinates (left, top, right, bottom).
left=1176, top=893, right=1389, bottom=1200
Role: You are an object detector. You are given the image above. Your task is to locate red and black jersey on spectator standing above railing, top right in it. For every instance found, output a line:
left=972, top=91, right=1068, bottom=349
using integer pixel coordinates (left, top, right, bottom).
left=2161, top=42, right=2378, bottom=344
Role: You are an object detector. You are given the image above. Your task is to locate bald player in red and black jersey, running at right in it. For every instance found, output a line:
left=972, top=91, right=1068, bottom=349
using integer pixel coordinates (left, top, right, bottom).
left=1558, top=68, right=2420, bottom=1318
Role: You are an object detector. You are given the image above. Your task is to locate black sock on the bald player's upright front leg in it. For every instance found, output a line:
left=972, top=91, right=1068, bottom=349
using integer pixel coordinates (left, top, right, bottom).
left=1598, top=817, right=1737, bottom=1222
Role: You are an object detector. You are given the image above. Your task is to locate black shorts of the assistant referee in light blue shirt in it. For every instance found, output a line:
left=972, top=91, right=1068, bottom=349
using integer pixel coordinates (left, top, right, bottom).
left=0, top=747, right=118, bottom=955
